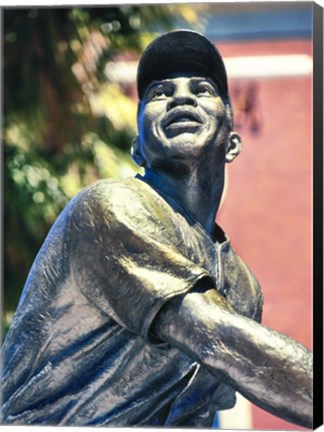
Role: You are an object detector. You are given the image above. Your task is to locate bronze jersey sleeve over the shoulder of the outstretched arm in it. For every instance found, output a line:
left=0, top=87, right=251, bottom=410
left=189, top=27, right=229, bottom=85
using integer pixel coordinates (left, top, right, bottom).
left=69, top=182, right=215, bottom=338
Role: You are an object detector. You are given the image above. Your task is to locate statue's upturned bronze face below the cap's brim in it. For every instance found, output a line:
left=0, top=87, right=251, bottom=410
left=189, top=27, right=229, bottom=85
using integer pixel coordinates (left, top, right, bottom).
left=138, top=74, right=229, bottom=166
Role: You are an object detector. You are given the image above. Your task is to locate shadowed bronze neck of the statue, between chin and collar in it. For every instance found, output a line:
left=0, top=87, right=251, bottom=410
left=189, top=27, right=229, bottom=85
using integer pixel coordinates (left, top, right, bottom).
left=144, top=166, right=224, bottom=236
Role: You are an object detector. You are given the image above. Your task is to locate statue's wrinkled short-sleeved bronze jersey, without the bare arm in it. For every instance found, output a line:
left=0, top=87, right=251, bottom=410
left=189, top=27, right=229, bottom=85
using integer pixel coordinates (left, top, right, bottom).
left=2, top=177, right=262, bottom=426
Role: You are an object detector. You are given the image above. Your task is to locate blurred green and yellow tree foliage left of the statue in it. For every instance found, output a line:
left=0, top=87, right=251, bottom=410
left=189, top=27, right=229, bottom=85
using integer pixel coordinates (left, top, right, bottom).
left=2, top=5, right=199, bottom=336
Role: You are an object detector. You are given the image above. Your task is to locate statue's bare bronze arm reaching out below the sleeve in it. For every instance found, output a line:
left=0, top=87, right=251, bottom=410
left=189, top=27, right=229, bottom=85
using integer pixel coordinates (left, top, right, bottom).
left=153, top=289, right=313, bottom=428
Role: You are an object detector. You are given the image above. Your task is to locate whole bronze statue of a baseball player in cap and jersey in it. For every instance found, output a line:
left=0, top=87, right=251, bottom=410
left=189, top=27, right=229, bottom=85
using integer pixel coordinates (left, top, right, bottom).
left=2, top=30, right=312, bottom=427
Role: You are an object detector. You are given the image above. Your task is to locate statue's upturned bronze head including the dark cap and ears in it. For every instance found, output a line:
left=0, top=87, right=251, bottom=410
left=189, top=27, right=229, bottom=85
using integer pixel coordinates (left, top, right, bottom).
left=132, top=30, right=240, bottom=167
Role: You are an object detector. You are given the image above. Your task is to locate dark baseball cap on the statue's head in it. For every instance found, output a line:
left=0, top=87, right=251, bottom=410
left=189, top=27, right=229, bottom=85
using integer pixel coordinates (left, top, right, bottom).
left=137, top=29, right=228, bottom=100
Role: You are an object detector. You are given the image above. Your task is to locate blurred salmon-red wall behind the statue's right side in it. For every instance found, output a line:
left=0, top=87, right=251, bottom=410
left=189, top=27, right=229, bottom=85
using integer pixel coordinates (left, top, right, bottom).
left=218, top=40, right=312, bottom=430
